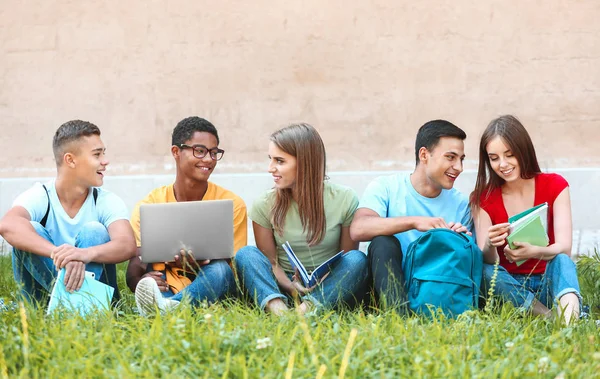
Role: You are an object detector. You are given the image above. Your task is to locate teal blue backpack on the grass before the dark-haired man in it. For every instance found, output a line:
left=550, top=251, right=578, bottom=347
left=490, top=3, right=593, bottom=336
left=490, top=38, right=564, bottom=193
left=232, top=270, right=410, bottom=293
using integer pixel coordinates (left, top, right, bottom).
left=404, top=229, right=483, bottom=317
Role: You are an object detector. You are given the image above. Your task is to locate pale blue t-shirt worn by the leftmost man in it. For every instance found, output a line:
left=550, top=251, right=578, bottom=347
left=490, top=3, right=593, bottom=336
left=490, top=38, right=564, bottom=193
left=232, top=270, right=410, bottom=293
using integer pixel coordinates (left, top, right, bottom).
left=13, top=180, right=129, bottom=246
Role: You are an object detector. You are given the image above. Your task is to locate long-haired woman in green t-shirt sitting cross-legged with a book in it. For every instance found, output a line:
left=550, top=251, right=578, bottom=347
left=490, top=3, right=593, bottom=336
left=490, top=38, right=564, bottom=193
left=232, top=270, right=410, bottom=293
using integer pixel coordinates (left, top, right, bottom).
left=235, top=124, right=368, bottom=314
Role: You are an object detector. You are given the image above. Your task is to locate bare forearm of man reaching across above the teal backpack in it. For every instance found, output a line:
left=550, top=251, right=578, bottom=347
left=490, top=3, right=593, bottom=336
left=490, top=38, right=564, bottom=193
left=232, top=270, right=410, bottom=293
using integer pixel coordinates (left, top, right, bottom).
left=350, top=216, right=414, bottom=242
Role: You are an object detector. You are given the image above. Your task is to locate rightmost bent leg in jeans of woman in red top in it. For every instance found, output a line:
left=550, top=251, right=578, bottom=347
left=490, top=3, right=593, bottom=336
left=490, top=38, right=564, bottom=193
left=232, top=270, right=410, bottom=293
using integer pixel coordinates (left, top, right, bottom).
left=540, top=254, right=582, bottom=325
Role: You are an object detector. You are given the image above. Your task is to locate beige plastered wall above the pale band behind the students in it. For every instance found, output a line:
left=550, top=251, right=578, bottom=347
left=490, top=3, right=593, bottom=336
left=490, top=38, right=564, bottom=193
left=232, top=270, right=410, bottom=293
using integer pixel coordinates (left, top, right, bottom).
left=0, top=0, right=600, bottom=177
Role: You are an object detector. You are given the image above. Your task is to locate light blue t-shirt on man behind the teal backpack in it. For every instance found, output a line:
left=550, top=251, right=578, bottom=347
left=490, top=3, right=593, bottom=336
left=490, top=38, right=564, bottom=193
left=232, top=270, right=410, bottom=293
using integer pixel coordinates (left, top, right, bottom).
left=358, top=173, right=473, bottom=252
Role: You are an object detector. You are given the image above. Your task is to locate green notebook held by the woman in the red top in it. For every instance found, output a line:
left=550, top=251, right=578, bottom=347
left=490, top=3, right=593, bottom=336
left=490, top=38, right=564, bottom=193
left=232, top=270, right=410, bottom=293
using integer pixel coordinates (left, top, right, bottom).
left=506, top=203, right=550, bottom=266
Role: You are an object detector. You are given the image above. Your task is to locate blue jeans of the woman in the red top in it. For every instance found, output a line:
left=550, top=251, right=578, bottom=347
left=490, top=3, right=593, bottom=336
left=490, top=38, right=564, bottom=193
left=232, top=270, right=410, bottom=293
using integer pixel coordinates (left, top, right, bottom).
left=482, top=254, right=582, bottom=310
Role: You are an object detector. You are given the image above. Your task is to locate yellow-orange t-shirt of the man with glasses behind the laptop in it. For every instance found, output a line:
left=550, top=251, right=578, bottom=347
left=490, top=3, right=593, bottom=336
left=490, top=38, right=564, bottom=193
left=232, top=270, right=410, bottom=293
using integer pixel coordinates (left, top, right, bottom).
left=130, top=182, right=248, bottom=292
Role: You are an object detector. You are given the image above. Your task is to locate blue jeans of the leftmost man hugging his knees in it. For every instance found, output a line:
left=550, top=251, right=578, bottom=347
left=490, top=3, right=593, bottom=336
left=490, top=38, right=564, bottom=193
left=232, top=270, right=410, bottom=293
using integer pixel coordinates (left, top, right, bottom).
left=12, top=221, right=120, bottom=303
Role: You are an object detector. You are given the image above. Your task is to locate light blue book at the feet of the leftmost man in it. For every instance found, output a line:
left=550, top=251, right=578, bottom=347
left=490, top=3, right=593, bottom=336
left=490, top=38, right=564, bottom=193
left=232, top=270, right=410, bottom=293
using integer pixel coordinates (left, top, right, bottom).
left=48, top=268, right=115, bottom=315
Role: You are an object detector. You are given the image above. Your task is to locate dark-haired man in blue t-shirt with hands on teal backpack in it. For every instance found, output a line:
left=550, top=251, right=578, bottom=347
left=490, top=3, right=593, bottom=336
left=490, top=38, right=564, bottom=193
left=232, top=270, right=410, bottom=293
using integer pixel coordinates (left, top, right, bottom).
left=350, top=120, right=472, bottom=311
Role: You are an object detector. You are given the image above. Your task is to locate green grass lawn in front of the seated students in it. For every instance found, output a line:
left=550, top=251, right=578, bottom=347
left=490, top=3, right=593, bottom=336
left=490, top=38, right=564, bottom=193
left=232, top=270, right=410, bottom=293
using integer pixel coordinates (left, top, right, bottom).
left=0, top=257, right=600, bottom=378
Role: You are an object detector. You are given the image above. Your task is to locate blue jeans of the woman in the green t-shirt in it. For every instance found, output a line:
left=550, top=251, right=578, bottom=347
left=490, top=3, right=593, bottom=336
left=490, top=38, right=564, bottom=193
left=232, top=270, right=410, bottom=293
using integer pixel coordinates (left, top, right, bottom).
left=234, top=246, right=368, bottom=309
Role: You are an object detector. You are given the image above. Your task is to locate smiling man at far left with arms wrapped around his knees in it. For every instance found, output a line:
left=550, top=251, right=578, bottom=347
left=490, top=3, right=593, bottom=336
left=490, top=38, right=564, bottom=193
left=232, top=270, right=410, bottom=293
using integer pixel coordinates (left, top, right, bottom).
left=0, top=120, right=136, bottom=303
